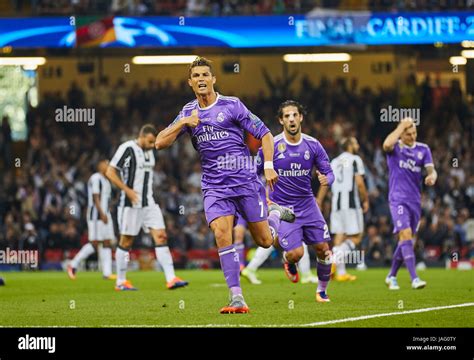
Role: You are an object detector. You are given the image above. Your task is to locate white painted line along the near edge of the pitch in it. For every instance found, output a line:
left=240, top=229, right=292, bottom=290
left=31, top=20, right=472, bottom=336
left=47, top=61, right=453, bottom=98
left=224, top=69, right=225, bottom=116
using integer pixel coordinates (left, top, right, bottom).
left=0, top=303, right=474, bottom=328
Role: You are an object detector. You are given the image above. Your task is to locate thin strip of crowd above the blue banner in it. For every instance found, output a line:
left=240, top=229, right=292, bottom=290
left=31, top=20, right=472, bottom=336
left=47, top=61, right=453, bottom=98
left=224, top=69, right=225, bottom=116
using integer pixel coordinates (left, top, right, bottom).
left=7, top=0, right=474, bottom=16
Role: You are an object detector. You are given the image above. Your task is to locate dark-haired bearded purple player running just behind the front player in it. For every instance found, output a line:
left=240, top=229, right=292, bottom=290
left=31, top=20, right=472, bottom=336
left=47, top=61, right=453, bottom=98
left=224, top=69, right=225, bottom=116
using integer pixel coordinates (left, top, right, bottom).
left=257, top=100, right=334, bottom=302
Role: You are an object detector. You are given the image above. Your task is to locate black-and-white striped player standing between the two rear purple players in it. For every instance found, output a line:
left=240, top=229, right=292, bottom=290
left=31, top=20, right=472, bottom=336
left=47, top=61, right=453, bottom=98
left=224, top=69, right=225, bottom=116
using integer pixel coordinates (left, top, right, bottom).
left=318, top=137, right=369, bottom=281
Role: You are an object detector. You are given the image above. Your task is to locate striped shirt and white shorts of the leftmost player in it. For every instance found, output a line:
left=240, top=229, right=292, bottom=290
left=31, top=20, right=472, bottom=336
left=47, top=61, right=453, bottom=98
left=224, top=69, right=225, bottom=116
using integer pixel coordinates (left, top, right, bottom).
left=87, top=172, right=115, bottom=241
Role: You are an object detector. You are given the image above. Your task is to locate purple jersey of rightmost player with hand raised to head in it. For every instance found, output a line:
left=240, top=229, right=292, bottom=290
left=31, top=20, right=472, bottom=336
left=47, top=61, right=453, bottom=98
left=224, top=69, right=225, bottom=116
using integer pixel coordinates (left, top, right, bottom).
left=387, top=141, right=433, bottom=203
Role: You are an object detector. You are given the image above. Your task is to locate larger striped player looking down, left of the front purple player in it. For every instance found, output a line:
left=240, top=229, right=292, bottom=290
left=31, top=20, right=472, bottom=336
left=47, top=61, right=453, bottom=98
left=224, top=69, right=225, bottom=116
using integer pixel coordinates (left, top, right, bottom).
left=106, top=124, right=188, bottom=291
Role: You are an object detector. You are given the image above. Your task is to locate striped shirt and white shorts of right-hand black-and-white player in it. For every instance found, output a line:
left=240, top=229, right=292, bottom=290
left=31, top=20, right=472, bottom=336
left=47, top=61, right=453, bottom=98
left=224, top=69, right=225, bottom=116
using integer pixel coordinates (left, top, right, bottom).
left=330, top=151, right=365, bottom=235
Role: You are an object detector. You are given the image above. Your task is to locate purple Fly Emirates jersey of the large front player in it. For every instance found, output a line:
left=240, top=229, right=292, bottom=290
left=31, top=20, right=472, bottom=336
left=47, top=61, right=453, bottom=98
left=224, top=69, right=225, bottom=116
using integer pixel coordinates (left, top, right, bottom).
left=174, top=94, right=270, bottom=190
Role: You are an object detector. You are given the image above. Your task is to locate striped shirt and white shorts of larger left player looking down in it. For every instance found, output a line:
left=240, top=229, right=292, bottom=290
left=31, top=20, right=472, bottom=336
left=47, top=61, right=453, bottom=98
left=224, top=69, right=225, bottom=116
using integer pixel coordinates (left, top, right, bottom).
left=110, top=140, right=165, bottom=236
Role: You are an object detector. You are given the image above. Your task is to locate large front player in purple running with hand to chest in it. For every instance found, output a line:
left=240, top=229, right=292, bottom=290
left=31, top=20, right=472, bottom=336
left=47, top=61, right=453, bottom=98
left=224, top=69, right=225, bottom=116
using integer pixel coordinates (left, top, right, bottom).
left=155, top=57, right=294, bottom=314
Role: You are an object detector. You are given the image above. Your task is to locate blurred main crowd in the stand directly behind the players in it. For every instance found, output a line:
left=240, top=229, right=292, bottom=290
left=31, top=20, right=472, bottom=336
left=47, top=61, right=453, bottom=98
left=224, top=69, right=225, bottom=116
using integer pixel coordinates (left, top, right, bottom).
left=0, top=74, right=474, bottom=265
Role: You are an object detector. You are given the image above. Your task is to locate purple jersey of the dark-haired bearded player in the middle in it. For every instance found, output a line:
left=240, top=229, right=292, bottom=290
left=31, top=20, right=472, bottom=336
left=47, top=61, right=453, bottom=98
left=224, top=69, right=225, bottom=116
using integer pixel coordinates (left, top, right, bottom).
left=256, top=133, right=334, bottom=221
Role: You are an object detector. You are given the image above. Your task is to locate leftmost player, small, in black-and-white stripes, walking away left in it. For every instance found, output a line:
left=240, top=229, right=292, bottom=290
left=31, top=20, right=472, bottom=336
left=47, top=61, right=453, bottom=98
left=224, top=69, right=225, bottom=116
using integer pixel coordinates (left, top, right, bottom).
left=67, top=160, right=115, bottom=280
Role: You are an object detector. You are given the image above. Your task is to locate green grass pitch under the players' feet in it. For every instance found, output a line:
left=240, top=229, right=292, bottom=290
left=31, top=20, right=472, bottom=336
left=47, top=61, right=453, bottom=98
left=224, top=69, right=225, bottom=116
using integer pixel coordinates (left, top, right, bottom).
left=0, top=269, right=474, bottom=328
